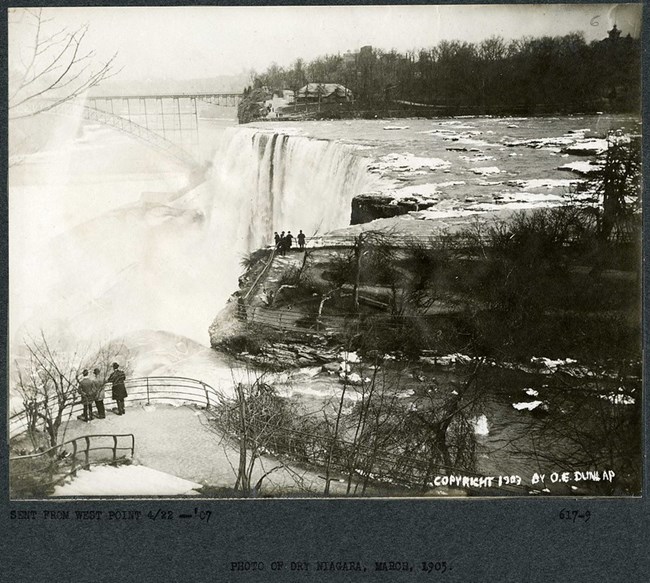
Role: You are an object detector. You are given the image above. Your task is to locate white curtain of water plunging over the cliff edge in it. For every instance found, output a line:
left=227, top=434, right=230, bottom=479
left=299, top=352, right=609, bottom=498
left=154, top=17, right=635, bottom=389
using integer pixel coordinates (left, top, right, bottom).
left=211, top=128, right=376, bottom=252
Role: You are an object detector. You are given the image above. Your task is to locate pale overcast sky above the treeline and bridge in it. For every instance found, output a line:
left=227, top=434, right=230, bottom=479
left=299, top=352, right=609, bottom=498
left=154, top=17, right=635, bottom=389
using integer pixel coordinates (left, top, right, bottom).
left=9, top=4, right=641, bottom=80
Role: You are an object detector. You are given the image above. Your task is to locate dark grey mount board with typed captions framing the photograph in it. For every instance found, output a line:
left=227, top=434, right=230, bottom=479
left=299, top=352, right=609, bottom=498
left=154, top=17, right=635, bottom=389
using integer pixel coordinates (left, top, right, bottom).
left=0, top=0, right=650, bottom=583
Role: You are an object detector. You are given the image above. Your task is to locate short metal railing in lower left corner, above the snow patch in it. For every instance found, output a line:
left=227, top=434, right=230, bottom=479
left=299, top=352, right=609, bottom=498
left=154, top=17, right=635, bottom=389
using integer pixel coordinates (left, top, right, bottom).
left=9, top=433, right=135, bottom=498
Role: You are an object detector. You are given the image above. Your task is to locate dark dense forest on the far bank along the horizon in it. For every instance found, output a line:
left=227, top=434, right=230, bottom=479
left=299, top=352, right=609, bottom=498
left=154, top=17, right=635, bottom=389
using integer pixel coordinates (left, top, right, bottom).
left=253, top=26, right=641, bottom=113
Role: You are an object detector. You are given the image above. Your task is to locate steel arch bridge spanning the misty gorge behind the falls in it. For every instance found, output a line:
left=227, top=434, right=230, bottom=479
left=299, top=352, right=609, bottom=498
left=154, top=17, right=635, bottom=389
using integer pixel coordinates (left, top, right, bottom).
left=53, top=93, right=241, bottom=167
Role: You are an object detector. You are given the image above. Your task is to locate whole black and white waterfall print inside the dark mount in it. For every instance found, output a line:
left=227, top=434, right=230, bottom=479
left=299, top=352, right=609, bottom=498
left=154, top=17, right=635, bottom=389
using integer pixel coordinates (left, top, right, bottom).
left=7, top=3, right=644, bottom=502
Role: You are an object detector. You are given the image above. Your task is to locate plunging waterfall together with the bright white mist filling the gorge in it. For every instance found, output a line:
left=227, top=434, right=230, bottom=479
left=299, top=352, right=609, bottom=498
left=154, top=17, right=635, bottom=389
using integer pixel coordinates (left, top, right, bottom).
left=9, top=113, right=372, bottom=346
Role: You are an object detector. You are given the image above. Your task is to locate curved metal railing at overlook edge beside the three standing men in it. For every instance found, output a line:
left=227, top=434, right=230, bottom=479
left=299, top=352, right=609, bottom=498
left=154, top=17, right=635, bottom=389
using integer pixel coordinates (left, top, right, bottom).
left=9, top=376, right=223, bottom=438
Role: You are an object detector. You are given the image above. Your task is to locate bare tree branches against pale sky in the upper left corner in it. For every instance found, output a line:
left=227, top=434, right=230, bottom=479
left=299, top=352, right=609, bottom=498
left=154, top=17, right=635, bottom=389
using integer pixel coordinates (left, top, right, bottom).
left=9, top=8, right=117, bottom=120
